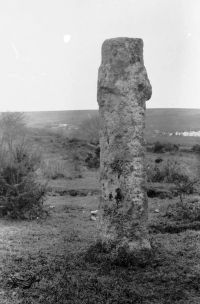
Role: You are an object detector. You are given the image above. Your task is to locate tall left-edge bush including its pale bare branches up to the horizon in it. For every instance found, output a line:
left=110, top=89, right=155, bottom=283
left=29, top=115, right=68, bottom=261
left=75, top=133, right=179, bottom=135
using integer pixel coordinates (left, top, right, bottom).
left=0, top=113, right=47, bottom=219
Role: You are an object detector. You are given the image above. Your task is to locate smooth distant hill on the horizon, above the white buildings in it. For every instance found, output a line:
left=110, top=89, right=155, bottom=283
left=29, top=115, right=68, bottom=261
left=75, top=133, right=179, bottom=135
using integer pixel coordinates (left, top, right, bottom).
left=26, top=109, right=200, bottom=132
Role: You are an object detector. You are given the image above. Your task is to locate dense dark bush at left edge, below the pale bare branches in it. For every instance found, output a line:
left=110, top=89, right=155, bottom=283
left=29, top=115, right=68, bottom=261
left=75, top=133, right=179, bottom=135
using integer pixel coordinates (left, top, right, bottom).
left=0, top=145, right=47, bottom=219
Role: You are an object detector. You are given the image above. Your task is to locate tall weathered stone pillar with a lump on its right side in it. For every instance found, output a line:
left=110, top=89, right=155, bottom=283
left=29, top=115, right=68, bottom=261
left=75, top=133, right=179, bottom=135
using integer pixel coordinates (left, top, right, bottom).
left=97, top=38, right=152, bottom=252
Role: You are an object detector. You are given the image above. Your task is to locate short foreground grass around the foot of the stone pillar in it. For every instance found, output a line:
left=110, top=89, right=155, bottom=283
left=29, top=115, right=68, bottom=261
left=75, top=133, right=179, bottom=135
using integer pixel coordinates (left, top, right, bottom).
left=0, top=196, right=200, bottom=304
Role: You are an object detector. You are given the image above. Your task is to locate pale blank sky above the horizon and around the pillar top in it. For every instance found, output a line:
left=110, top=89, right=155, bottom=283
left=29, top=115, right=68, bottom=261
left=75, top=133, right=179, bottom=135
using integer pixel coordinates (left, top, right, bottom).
left=0, top=0, right=200, bottom=111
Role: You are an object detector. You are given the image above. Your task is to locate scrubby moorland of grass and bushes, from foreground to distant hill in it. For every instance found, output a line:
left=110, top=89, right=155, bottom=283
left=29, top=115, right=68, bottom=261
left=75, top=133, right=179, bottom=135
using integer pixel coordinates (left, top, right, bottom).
left=0, top=114, right=200, bottom=304
